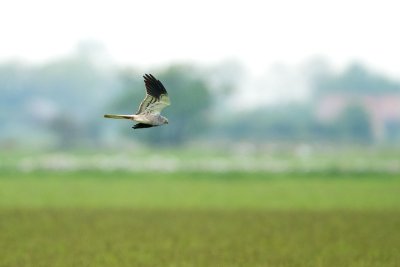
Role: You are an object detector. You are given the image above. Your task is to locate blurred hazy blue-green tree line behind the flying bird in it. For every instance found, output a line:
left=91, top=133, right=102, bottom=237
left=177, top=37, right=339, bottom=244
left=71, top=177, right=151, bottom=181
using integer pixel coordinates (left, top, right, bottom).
left=0, top=51, right=400, bottom=149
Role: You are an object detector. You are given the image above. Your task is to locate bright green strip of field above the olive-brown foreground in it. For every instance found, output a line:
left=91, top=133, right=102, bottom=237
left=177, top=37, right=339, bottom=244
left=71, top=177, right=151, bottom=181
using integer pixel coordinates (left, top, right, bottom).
left=0, top=171, right=400, bottom=211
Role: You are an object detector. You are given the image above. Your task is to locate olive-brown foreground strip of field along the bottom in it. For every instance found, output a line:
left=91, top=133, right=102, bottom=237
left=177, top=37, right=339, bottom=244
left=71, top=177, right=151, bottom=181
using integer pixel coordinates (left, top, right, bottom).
left=0, top=209, right=400, bottom=267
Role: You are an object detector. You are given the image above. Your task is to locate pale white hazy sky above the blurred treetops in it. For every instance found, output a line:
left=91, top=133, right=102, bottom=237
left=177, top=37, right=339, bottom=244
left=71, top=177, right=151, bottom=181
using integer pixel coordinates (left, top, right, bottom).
left=0, top=0, right=400, bottom=77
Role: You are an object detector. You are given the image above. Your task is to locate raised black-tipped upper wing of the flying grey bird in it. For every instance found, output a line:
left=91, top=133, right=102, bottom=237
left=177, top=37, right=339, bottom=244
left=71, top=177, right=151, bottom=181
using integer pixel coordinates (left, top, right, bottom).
left=136, top=74, right=171, bottom=114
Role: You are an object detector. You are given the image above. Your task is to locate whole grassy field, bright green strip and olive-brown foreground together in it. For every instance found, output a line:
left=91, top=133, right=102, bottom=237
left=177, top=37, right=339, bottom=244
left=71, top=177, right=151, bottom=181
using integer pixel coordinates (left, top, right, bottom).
left=0, top=170, right=400, bottom=267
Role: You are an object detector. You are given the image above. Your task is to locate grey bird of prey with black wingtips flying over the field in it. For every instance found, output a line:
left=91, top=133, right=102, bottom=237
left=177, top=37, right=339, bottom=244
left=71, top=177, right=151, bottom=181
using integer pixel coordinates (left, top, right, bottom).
left=104, top=74, right=171, bottom=129
